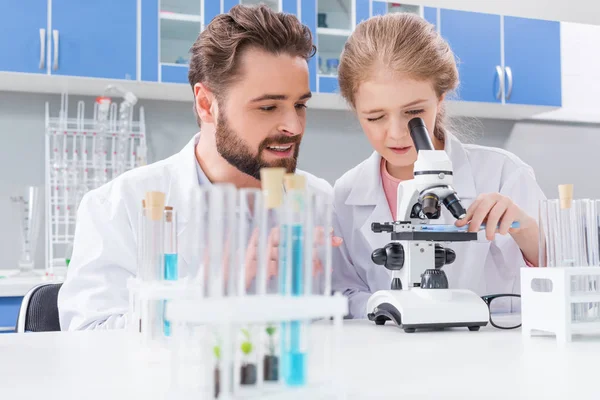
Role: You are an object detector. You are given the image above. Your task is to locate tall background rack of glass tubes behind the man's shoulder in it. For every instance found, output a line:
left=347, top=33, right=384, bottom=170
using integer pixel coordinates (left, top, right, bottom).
left=45, top=93, right=147, bottom=278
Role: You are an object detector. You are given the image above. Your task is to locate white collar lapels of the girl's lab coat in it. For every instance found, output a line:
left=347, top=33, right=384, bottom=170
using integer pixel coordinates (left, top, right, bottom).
left=345, top=133, right=476, bottom=206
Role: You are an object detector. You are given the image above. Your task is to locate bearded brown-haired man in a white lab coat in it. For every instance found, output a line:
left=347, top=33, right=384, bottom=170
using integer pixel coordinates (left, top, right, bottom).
left=58, top=6, right=340, bottom=330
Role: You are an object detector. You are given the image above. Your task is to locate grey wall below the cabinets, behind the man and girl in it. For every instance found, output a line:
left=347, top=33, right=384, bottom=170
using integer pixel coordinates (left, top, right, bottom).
left=0, top=92, right=600, bottom=269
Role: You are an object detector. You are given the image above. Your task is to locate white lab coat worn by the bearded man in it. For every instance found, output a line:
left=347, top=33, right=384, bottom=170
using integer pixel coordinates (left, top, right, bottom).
left=58, top=135, right=332, bottom=330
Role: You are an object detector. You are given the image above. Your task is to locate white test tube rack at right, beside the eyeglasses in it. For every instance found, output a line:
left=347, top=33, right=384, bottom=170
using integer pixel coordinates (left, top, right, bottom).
left=521, top=266, right=600, bottom=344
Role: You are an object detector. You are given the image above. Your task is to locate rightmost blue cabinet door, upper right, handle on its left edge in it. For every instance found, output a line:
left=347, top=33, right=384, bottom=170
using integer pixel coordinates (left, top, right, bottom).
left=504, top=17, right=562, bottom=107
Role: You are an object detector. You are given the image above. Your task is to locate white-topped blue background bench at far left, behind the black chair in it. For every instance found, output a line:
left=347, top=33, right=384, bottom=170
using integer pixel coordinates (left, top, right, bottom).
left=0, top=269, right=66, bottom=333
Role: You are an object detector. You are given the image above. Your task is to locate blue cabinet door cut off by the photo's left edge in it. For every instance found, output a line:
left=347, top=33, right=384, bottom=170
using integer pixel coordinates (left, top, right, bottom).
left=0, top=0, right=48, bottom=73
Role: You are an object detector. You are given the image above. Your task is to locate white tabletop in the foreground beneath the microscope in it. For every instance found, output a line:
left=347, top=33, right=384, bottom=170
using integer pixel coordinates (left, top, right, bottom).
left=0, top=321, right=600, bottom=400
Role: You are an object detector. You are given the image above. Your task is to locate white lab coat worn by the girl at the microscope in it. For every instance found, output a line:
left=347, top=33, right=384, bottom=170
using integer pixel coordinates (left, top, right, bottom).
left=333, top=134, right=545, bottom=318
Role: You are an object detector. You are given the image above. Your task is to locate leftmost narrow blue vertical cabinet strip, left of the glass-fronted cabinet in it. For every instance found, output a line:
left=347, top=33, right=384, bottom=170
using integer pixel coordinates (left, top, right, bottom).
left=142, top=0, right=160, bottom=82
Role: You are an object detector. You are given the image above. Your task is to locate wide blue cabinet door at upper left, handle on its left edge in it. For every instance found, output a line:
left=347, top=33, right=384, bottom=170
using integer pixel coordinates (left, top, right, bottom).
left=49, top=0, right=137, bottom=79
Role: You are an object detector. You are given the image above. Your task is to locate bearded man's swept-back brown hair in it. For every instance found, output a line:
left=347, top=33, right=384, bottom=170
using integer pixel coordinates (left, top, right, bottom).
left=188, top=4, right=316, bottom=101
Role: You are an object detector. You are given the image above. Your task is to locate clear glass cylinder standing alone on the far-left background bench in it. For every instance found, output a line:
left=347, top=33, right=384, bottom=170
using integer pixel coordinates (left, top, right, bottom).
left=11, top=186, right=44, bottom=277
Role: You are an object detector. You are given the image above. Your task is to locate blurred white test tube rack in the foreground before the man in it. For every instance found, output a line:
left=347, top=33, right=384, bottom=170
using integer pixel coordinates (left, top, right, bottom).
left=128, top=279, right=348, bottom=400
